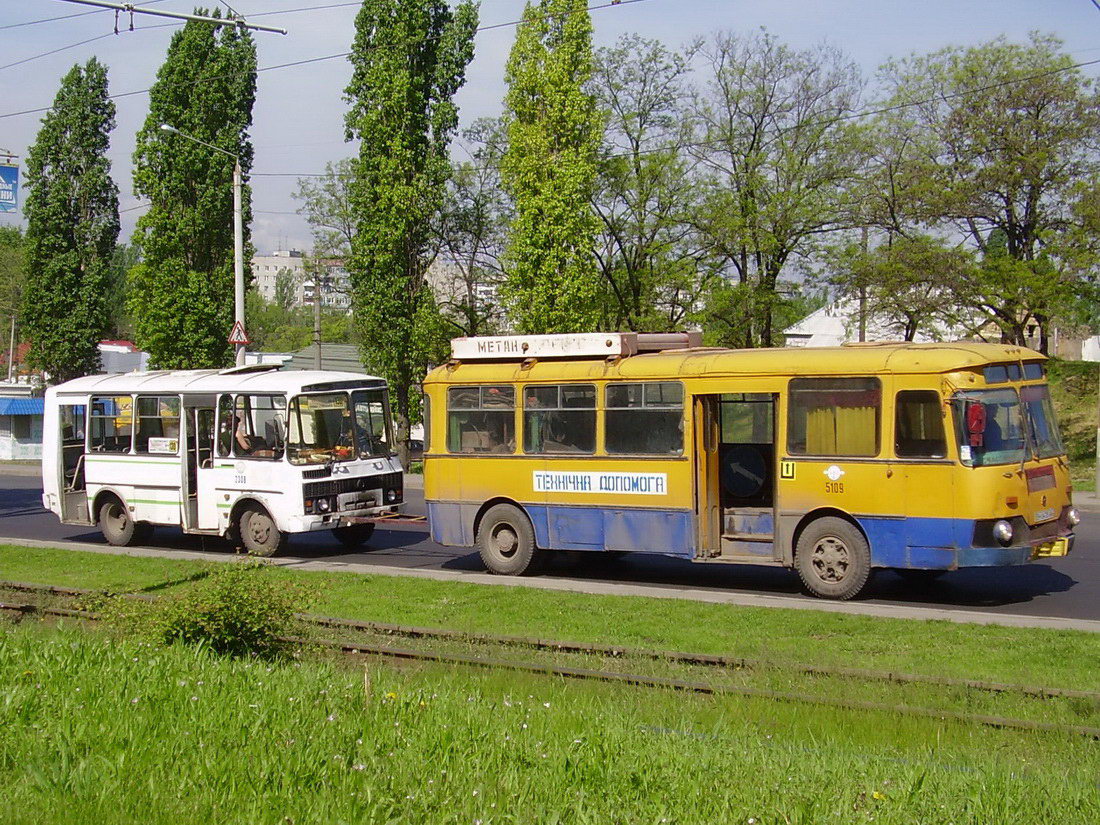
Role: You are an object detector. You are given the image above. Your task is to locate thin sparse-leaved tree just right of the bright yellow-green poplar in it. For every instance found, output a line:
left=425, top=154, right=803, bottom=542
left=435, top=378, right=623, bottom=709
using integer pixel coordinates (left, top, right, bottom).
left=593, top=35, right=712, bottom=332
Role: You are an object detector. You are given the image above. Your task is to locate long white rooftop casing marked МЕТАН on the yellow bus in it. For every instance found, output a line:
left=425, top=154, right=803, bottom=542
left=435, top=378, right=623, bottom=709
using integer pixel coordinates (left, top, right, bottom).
left=451, top=332, right=703, bottom=361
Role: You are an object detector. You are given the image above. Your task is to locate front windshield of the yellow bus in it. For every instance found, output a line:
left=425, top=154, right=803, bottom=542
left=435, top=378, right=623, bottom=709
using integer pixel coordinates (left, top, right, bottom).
left=954, top=385, right=1064, bottom=466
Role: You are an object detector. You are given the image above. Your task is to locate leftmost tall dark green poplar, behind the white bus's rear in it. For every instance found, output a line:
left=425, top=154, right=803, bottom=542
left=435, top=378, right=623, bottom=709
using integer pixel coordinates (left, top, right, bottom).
left=22, top=58, right=119, bottom=382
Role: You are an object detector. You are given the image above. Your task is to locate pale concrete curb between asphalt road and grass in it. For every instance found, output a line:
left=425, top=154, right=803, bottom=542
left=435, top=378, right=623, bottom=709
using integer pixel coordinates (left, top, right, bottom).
left=0, top=537, right=1100, bottom=634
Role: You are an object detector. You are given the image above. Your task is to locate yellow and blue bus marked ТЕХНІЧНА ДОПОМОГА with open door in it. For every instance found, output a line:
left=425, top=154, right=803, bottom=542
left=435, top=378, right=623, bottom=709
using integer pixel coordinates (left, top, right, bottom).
left=425, top=333, right=1080, bottom=598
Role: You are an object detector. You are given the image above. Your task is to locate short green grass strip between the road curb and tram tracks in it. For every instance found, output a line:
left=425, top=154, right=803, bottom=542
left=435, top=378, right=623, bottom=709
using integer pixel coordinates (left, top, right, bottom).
left=0, top=546, right=1100, bottom=690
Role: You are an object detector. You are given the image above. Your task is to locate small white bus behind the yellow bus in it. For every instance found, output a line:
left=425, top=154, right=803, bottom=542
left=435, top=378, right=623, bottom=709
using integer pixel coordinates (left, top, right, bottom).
left=42, top=365, right=403, bottom=556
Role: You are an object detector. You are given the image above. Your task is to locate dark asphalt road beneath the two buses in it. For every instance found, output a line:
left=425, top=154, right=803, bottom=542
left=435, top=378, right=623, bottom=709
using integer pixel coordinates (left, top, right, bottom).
left=0, top=474, right=1100, bottom=620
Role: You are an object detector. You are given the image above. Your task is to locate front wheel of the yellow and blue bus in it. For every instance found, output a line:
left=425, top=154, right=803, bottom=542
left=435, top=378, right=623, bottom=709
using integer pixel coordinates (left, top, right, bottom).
left=794, top=516, right=871, bottom=601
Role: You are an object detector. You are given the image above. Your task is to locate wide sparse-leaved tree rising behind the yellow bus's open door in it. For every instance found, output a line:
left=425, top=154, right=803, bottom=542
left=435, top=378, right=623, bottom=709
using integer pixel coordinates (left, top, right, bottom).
left=691, top=32, right=867, bottom=347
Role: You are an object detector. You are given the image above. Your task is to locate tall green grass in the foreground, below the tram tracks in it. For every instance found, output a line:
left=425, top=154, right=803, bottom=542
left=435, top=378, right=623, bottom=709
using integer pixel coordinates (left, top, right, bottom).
left=0, top=625, right=1100, bottom=825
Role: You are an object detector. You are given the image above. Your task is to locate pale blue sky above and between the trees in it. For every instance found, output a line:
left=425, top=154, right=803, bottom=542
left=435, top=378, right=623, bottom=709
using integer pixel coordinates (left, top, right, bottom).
left=0, top=0, right=1100, bottom=253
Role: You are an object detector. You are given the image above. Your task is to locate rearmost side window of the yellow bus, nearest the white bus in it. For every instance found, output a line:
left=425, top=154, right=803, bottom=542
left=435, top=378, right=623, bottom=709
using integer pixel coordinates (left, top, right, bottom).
left=447, top=385, right=516, bottom=453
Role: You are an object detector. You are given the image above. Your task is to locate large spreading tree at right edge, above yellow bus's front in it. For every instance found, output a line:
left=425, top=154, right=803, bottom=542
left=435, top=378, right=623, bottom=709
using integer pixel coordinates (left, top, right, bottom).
left=880, top=34, right=1100, bottom=350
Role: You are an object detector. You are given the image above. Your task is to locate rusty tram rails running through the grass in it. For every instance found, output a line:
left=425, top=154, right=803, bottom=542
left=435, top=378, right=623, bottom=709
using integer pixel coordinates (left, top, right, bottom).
left=0, top=582, right=1100, bottom=739
